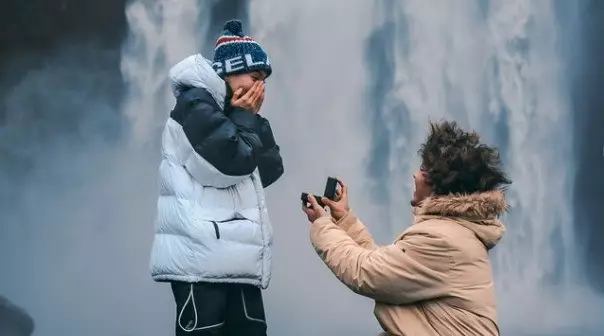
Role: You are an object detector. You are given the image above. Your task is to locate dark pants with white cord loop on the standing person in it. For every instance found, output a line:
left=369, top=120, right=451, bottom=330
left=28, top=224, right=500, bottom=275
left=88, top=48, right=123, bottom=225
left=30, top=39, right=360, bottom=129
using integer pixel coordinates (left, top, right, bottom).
left=172, top=282, right=266, bottom=336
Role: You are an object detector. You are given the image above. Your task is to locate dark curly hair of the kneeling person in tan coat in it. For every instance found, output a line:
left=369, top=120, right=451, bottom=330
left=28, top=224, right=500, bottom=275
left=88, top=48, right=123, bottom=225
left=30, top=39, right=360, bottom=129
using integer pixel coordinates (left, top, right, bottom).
left=418, top=121, right=512, bottom=195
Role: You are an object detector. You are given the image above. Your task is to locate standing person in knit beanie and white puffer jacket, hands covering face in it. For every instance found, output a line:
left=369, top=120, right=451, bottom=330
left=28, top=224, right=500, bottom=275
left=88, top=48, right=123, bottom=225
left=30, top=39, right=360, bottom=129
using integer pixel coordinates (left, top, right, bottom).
left=151, top=20, right=283, bottom=336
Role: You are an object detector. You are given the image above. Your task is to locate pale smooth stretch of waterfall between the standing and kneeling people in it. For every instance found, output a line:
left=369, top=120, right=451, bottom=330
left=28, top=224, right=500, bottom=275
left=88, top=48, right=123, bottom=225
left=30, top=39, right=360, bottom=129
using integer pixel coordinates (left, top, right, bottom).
left=249, top=0, right=384, bottom=336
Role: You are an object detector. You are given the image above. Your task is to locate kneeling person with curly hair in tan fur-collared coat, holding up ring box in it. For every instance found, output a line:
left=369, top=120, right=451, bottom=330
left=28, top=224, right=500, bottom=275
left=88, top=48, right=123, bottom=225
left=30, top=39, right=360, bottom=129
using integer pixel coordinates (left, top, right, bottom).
left=303, top=122, right=511, bottom=336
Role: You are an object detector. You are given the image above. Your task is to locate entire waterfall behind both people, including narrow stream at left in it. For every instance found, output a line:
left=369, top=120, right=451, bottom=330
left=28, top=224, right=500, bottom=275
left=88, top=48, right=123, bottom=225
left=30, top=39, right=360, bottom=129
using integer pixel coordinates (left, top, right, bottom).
left=122, top=0, right=595, bottom=336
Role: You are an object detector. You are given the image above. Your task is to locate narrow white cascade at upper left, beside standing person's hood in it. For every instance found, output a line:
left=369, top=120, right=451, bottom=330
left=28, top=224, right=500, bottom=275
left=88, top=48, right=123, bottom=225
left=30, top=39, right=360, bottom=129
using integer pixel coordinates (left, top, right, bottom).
left=121, top=0, right=212, bottom=144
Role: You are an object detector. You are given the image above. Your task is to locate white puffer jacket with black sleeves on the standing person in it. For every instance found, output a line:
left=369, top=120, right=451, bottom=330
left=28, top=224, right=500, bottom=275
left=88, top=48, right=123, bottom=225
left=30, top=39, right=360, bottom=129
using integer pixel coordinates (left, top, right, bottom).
left=151, top=55, right=283, bottom=288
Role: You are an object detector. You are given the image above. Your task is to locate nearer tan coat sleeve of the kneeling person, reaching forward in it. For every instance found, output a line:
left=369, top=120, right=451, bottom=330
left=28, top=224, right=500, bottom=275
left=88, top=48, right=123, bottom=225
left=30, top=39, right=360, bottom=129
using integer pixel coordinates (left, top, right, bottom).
left=311, top=217, right=452, bottom=304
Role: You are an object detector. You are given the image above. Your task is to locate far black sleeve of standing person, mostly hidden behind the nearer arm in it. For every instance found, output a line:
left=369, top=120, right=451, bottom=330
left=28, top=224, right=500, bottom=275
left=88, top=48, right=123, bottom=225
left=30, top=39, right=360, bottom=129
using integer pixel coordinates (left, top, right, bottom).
left=257, top=116, right=284, bottom=188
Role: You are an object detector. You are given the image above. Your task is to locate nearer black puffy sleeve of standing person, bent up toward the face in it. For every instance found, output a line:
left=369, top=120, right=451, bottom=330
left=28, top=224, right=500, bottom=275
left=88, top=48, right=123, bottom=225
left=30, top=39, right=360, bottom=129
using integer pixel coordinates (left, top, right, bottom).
left=171, top=88, right=263, bottom=176
